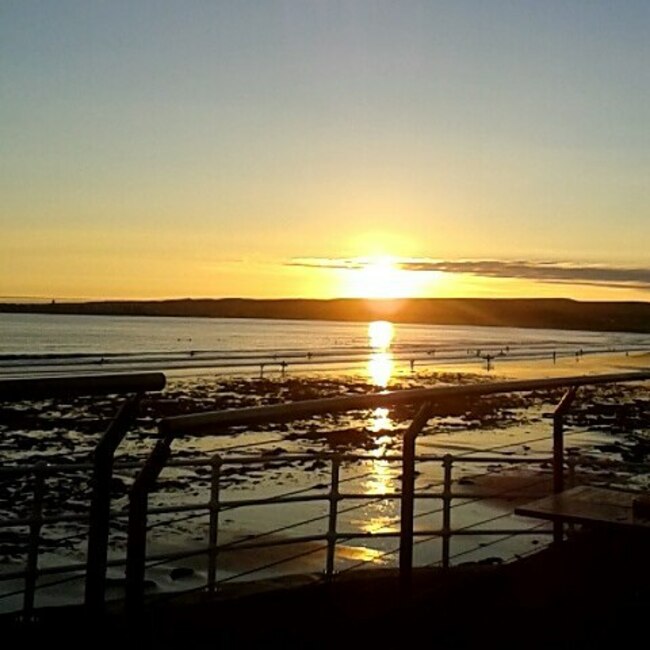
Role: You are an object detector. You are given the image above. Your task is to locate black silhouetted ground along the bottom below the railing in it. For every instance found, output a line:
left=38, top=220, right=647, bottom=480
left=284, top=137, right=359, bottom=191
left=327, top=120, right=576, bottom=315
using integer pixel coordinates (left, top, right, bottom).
left=2, top=533, right=650, bottom=650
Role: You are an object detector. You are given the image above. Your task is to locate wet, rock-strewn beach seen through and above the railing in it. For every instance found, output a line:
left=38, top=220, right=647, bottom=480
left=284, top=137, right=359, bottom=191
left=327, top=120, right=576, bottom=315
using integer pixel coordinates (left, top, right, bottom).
left=0, top=342, right=650, bottom=608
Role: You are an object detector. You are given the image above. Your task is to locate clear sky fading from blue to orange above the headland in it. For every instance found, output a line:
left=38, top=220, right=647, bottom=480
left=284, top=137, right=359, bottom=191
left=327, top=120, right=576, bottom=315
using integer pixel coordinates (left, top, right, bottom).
left=0, top=0, right=650, bottom=300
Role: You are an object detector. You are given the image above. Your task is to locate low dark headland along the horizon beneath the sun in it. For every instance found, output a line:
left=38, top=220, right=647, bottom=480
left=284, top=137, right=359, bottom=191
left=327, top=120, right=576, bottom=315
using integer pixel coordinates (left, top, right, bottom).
left=0, top=298, right=650, bottom=333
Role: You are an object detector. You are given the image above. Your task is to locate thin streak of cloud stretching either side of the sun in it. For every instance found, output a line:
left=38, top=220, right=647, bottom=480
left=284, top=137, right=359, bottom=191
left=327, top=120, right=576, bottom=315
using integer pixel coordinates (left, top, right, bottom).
left=289, top=258, right=650, bottom=290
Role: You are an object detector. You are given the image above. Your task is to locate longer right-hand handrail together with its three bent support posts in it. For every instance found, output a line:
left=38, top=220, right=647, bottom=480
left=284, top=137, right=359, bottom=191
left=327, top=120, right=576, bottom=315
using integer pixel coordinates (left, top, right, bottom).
left=126, top=372, right=650, bottom=616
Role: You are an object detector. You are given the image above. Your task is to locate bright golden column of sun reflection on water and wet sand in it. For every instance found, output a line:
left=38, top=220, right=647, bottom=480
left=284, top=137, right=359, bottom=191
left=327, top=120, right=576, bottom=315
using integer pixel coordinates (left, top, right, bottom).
left=358, top=321, right=399, bottom=540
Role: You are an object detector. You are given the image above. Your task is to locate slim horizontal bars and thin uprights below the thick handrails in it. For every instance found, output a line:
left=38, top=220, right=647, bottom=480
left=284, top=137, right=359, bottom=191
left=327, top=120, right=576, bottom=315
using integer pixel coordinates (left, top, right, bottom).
left=0, top=453, right=551, bottom=602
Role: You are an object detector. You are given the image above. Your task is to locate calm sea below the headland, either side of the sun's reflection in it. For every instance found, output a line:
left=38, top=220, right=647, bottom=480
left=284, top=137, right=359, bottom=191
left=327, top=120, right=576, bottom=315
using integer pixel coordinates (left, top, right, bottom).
left=0, top=314, right=650, bottom=377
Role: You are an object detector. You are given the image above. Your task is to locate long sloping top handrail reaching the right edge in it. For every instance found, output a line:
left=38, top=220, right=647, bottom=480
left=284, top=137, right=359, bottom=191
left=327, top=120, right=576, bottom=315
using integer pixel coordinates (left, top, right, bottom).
left=159, top=371, right=650, bottom=436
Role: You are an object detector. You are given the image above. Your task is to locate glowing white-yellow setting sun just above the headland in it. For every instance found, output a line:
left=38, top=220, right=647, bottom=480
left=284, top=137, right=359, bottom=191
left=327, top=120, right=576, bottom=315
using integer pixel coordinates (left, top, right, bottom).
left=346, top=256, right=419, bottom=299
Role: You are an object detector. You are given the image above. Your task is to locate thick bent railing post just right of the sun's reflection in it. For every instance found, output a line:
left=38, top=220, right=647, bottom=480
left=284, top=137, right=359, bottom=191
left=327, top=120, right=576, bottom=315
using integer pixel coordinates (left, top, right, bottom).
left=399, top=402, right=432, bottom=588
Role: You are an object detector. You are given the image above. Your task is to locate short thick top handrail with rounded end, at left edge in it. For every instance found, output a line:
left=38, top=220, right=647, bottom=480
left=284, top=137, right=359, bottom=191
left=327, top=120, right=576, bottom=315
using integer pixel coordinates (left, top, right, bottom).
left=0, top=372, right=167, bottom=402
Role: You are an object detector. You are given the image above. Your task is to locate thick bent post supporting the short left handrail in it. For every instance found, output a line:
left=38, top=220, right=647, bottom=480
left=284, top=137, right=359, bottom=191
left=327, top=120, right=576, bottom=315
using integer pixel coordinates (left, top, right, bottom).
left=85, top=395, right=140, bottom=615
